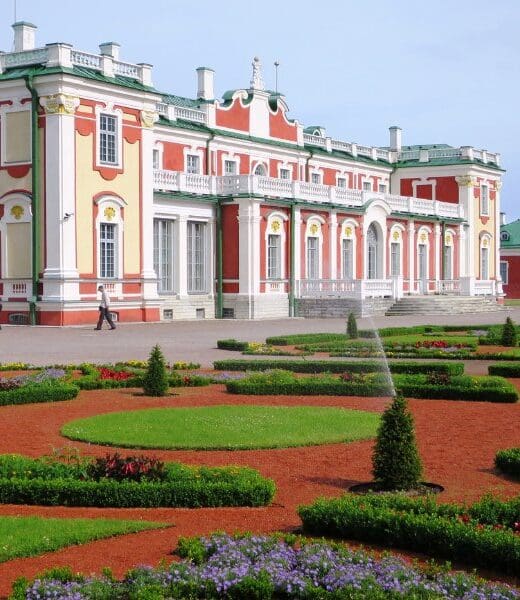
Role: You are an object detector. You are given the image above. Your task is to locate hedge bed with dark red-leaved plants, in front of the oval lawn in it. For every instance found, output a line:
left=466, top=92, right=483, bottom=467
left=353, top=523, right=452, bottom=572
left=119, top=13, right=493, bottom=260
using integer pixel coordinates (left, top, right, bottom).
left=0, top=455, right=275, bottom=508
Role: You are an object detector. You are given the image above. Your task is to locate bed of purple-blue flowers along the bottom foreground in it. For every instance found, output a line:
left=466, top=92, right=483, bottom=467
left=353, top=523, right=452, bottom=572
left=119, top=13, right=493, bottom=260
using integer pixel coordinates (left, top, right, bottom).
left=12, top=534, right=520, bottom=600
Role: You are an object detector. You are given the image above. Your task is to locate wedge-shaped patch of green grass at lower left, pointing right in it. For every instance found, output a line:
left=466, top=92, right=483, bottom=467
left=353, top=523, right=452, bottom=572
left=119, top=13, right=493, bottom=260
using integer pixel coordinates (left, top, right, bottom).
left=0, top=517, right=165, bottom=562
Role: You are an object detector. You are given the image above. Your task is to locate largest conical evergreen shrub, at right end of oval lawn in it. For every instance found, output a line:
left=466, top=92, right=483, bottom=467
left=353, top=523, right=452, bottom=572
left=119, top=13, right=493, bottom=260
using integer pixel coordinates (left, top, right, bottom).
left=372, top=396, right=422, bottom=490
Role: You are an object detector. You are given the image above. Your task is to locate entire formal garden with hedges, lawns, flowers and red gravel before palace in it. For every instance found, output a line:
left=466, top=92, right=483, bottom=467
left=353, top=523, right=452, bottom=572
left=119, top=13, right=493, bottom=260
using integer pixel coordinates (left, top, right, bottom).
left=0, top=325, right=520, bottom=600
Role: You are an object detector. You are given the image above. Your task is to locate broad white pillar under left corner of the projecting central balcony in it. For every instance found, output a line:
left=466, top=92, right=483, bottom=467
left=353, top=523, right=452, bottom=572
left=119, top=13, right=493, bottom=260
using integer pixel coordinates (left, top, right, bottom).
left=238, top=198, right=261, bottom=319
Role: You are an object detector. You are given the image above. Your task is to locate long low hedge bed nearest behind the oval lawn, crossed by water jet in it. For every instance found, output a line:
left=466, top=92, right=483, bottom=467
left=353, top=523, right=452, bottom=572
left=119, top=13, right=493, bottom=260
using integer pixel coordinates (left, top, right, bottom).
left=226, top=371, right=518, bottom=402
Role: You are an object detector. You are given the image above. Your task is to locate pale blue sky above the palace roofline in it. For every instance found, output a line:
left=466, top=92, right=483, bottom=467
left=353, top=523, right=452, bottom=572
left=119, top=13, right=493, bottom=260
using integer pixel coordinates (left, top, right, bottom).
left=0, top=0, right=520, bottom=221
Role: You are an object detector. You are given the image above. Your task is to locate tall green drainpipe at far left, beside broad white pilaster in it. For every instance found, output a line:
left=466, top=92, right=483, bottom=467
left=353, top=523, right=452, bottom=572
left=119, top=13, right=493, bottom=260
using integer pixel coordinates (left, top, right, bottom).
left=23, top=74, right=40, bottom=325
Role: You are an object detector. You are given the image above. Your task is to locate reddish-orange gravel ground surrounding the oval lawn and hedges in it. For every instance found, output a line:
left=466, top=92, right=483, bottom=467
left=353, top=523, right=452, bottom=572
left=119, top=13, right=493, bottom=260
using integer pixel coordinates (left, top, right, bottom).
left=0, top=380, right=520, bottom=596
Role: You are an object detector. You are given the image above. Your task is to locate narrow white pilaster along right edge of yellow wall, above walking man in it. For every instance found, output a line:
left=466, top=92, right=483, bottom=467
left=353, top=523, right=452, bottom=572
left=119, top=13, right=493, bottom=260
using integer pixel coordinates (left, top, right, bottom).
left=141, top=111, right=158, bottom=300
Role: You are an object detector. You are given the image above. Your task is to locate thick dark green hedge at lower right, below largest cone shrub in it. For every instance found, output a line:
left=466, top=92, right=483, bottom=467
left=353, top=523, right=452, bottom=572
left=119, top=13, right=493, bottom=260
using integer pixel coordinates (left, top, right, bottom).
left=298, top=495, right=520, bottom=574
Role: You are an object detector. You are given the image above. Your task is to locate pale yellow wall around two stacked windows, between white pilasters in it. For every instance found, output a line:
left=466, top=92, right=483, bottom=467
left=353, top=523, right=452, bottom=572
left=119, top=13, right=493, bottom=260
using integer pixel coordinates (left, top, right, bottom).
left=76, top=132, right=140, bottom=276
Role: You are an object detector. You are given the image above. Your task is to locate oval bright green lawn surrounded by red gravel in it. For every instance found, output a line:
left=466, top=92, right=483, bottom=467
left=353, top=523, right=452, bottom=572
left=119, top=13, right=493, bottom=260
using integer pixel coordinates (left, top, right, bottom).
left=61, top=406, right=379, bottom=450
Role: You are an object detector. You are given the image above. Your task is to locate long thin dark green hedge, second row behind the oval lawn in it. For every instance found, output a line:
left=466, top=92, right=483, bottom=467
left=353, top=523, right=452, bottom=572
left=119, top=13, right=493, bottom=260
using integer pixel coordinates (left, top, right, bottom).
left=213, top=359, right=464, bottom=375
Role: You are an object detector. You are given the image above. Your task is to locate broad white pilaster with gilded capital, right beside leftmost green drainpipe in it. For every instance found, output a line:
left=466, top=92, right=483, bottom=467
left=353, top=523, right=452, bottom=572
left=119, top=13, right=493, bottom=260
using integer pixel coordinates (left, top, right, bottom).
left=41, top=94, right=81, bottom=302
